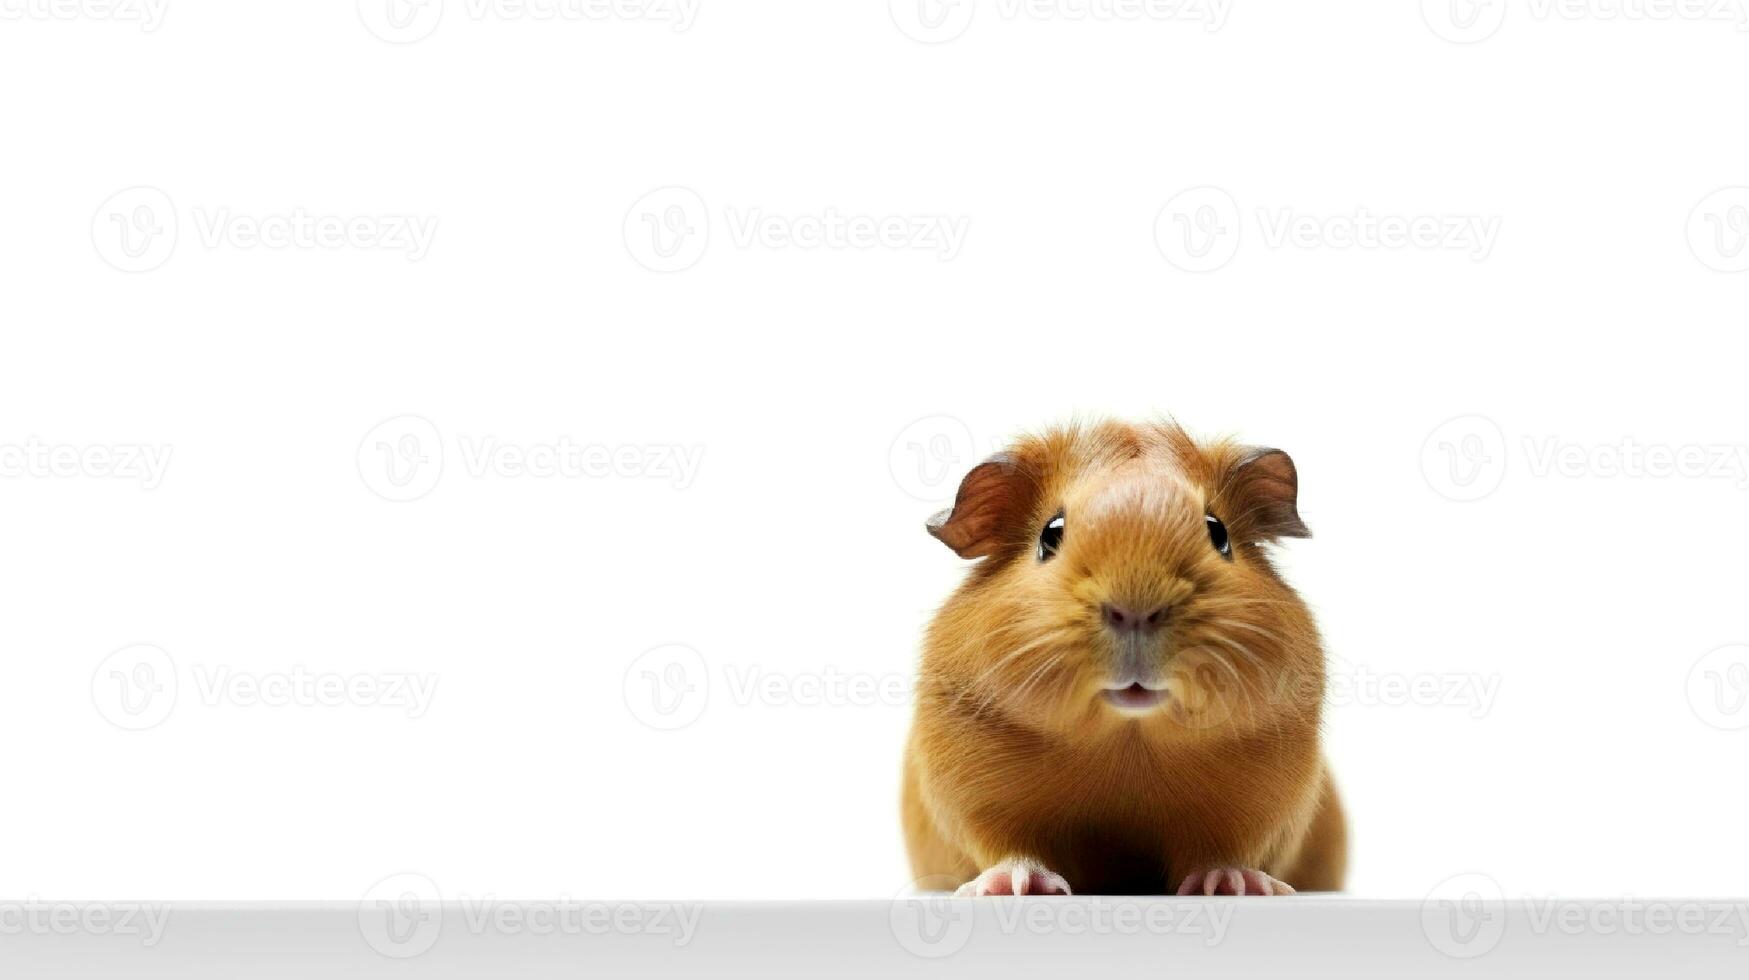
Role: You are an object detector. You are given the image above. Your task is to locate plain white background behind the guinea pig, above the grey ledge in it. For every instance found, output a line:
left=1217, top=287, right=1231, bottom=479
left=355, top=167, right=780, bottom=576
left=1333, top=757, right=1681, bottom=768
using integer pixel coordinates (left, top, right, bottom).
left=0, top=0, right=1749, bottom=900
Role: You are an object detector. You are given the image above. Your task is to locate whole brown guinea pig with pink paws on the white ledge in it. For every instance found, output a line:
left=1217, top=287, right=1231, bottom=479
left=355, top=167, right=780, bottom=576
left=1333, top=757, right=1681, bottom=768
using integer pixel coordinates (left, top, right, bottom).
left=902, top=422, right=1347, bottom=894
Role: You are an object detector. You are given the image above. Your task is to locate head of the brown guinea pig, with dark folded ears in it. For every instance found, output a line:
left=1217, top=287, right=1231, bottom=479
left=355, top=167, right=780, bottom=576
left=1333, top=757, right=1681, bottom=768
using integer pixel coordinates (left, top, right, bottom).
left=925, top=424, right=1322, bottom=735
